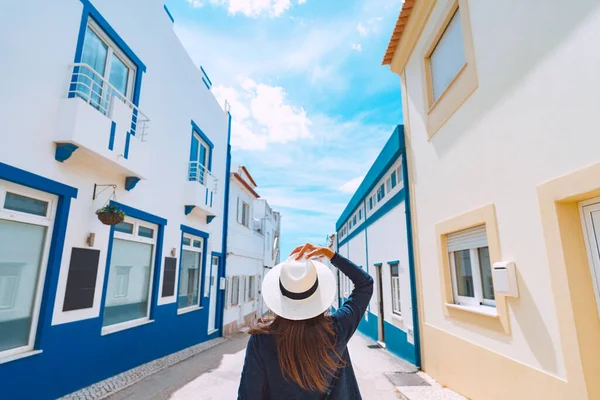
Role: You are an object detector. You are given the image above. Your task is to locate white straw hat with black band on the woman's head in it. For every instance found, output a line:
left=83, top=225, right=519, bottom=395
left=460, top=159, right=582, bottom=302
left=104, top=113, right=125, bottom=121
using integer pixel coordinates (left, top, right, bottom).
left=262, top=257, right=337, bottom=321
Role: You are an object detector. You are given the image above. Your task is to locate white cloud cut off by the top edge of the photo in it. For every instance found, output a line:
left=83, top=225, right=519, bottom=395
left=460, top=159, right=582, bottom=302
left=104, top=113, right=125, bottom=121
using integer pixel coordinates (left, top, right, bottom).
left=187, top=0, right=306, bottom=18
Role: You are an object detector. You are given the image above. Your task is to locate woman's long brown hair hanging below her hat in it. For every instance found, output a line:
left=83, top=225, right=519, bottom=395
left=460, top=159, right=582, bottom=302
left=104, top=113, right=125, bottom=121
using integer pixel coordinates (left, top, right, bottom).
left=249, top=314, right=344, bottom=392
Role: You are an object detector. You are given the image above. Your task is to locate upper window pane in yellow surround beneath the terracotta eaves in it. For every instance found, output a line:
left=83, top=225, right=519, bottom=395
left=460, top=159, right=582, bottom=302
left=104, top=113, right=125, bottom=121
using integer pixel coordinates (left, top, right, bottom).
left=429, top=9, right=466, bottom=101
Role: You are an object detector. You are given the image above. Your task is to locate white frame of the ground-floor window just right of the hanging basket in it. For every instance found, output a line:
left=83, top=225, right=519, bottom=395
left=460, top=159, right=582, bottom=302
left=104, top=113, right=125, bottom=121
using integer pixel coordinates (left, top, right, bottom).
left=101, top=216, right=158, bottom=335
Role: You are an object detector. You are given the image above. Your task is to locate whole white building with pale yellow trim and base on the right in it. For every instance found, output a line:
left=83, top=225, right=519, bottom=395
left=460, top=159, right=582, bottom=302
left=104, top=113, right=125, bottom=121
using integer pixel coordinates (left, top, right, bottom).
left=383, top=0, right=600, bottom=400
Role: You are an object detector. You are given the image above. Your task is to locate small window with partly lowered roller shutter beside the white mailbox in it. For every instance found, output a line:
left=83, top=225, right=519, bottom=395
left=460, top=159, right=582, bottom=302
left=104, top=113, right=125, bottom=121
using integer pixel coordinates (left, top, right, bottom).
left=446, top=225, right=496, bottom=306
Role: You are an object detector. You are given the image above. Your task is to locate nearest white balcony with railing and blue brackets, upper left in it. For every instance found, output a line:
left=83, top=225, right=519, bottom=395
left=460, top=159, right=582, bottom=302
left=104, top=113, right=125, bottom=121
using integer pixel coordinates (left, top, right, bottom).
left=54, top=63, right=150, bottom=186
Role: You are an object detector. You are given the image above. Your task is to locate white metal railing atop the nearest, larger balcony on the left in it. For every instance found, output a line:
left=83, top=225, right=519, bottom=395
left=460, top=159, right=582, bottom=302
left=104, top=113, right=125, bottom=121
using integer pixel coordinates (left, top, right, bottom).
left=68, top=63, right=150, bottom=142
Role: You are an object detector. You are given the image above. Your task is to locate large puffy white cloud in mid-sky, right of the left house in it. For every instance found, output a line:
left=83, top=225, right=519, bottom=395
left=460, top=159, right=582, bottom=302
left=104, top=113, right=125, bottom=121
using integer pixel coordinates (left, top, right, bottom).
left=212, top=78, right=312, bottom=150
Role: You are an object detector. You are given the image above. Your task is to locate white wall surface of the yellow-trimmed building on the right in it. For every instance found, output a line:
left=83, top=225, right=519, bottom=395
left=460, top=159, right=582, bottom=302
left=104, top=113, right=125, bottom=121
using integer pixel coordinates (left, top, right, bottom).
left=403, top=0, right=600, bottom=378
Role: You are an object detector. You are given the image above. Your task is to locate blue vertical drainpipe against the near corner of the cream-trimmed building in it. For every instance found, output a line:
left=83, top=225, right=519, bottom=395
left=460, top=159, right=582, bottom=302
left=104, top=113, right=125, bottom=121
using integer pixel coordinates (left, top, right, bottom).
left=402, top=126, right=421, bottom=368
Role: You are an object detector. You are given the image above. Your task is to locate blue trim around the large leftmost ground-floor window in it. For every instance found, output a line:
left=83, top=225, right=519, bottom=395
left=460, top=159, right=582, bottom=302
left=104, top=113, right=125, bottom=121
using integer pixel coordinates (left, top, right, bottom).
left=0, top=162, right=77, bottom=350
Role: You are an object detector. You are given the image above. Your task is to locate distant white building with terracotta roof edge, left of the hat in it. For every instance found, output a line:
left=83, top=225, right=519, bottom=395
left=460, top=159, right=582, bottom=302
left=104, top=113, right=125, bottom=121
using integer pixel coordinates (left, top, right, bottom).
left=223, top=166, right=281, bottom=335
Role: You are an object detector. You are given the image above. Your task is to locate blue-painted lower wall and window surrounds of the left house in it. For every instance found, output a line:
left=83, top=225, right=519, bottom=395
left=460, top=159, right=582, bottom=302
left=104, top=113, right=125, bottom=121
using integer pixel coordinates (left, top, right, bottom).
left=0, top=163, right=219, bottom=400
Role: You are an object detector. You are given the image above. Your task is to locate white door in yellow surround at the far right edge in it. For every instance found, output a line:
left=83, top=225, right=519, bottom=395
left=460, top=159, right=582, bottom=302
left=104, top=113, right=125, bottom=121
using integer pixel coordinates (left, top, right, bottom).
left=579, top=199, right=600, bottom=315
